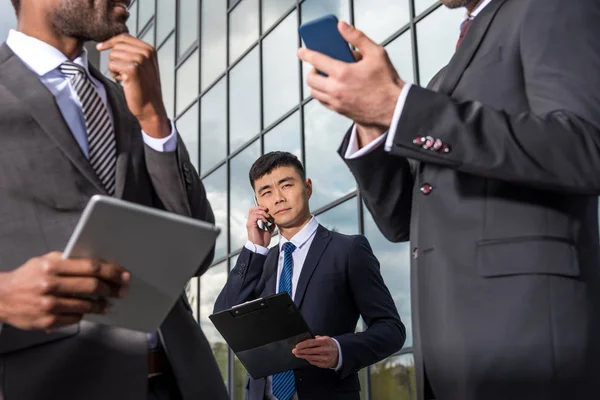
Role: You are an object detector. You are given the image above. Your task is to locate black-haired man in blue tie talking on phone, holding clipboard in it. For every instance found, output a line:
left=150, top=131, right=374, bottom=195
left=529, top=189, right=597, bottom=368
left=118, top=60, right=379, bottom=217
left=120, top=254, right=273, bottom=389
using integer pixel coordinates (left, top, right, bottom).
left=215, top=152, right=406, bottom=400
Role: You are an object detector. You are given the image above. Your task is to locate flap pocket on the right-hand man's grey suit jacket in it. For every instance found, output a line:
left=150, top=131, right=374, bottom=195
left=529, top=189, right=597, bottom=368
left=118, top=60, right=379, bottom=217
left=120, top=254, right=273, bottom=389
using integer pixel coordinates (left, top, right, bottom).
left=477, top=236, right=579, bottom=278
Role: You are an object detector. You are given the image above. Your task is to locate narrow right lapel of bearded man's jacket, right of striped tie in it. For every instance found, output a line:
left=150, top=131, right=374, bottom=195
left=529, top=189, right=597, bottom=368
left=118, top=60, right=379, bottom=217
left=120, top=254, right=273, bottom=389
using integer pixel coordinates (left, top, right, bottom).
left=89, top=65, right=134, bottom=198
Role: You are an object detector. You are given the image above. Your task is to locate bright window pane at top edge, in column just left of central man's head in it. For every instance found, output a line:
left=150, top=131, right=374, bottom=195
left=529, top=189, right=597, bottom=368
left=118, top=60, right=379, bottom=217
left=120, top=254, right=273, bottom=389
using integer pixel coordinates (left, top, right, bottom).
left=229, top=0, right=258, bottom=64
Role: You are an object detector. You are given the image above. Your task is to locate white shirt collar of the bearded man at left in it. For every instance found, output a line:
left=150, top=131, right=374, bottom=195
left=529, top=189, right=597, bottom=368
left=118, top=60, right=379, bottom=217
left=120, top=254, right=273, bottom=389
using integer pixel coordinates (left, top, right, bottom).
left=6, top=29, right=90, bottom=77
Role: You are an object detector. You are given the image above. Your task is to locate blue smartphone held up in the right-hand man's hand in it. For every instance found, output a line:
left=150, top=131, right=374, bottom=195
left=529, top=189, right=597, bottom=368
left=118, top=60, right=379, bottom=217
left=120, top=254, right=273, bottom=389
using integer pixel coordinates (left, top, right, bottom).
left=298, top=14, right=356, bottom=76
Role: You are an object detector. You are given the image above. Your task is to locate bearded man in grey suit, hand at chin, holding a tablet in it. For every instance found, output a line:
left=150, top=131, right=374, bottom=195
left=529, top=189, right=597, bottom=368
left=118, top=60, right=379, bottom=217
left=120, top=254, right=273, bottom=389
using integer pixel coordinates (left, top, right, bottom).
left=0, top=0, right=228, bottom=400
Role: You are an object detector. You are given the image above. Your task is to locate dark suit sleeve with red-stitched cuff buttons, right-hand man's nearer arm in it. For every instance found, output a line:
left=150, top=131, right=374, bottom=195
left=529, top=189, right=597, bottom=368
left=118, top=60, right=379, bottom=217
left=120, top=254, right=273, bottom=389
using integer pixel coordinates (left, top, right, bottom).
left=391, top=0, right=600, bottom=195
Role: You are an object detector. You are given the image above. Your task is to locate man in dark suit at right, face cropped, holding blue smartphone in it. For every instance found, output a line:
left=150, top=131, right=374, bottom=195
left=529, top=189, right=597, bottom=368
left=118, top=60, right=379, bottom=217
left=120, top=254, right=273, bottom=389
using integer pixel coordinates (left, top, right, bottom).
left=300, top=0, right=600, bottom=400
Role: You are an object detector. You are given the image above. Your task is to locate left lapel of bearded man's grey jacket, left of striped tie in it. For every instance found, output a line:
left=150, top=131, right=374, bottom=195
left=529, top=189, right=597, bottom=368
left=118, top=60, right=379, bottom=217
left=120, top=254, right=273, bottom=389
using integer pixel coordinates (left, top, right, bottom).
left=0, top=43, right=106, bottom=194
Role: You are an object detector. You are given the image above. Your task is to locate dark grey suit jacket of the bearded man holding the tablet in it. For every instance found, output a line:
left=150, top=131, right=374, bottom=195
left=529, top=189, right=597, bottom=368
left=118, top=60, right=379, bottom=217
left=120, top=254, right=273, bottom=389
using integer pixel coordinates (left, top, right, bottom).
left=0, top=44, right=228, bottom=400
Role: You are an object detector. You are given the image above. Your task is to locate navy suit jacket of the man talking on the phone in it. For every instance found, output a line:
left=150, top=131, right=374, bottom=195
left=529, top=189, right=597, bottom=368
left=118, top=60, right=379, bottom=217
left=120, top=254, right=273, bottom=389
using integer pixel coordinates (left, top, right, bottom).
left=215, top=225, right=406, bottom=400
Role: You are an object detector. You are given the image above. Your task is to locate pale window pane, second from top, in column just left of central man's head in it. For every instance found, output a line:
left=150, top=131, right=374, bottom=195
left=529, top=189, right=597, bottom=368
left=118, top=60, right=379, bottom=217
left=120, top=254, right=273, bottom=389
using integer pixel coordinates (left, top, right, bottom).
left=229, top=48, right=261, bottom=153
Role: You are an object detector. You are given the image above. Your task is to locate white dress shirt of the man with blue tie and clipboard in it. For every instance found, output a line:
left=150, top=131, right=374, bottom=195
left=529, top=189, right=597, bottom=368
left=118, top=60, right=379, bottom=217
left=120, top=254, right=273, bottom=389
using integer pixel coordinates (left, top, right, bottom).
left=245, top=217, right=343, bottom=400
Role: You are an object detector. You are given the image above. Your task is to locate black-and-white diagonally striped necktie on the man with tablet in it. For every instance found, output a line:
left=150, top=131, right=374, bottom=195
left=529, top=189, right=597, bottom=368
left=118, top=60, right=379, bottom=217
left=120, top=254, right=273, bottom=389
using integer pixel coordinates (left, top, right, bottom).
left=59, top=61, right=117, bottom=196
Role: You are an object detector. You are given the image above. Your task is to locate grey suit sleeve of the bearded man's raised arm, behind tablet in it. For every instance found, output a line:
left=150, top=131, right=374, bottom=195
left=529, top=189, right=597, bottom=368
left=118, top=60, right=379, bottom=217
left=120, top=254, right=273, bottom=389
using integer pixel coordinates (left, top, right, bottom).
left=144, top=137, right=215, bottom=276
